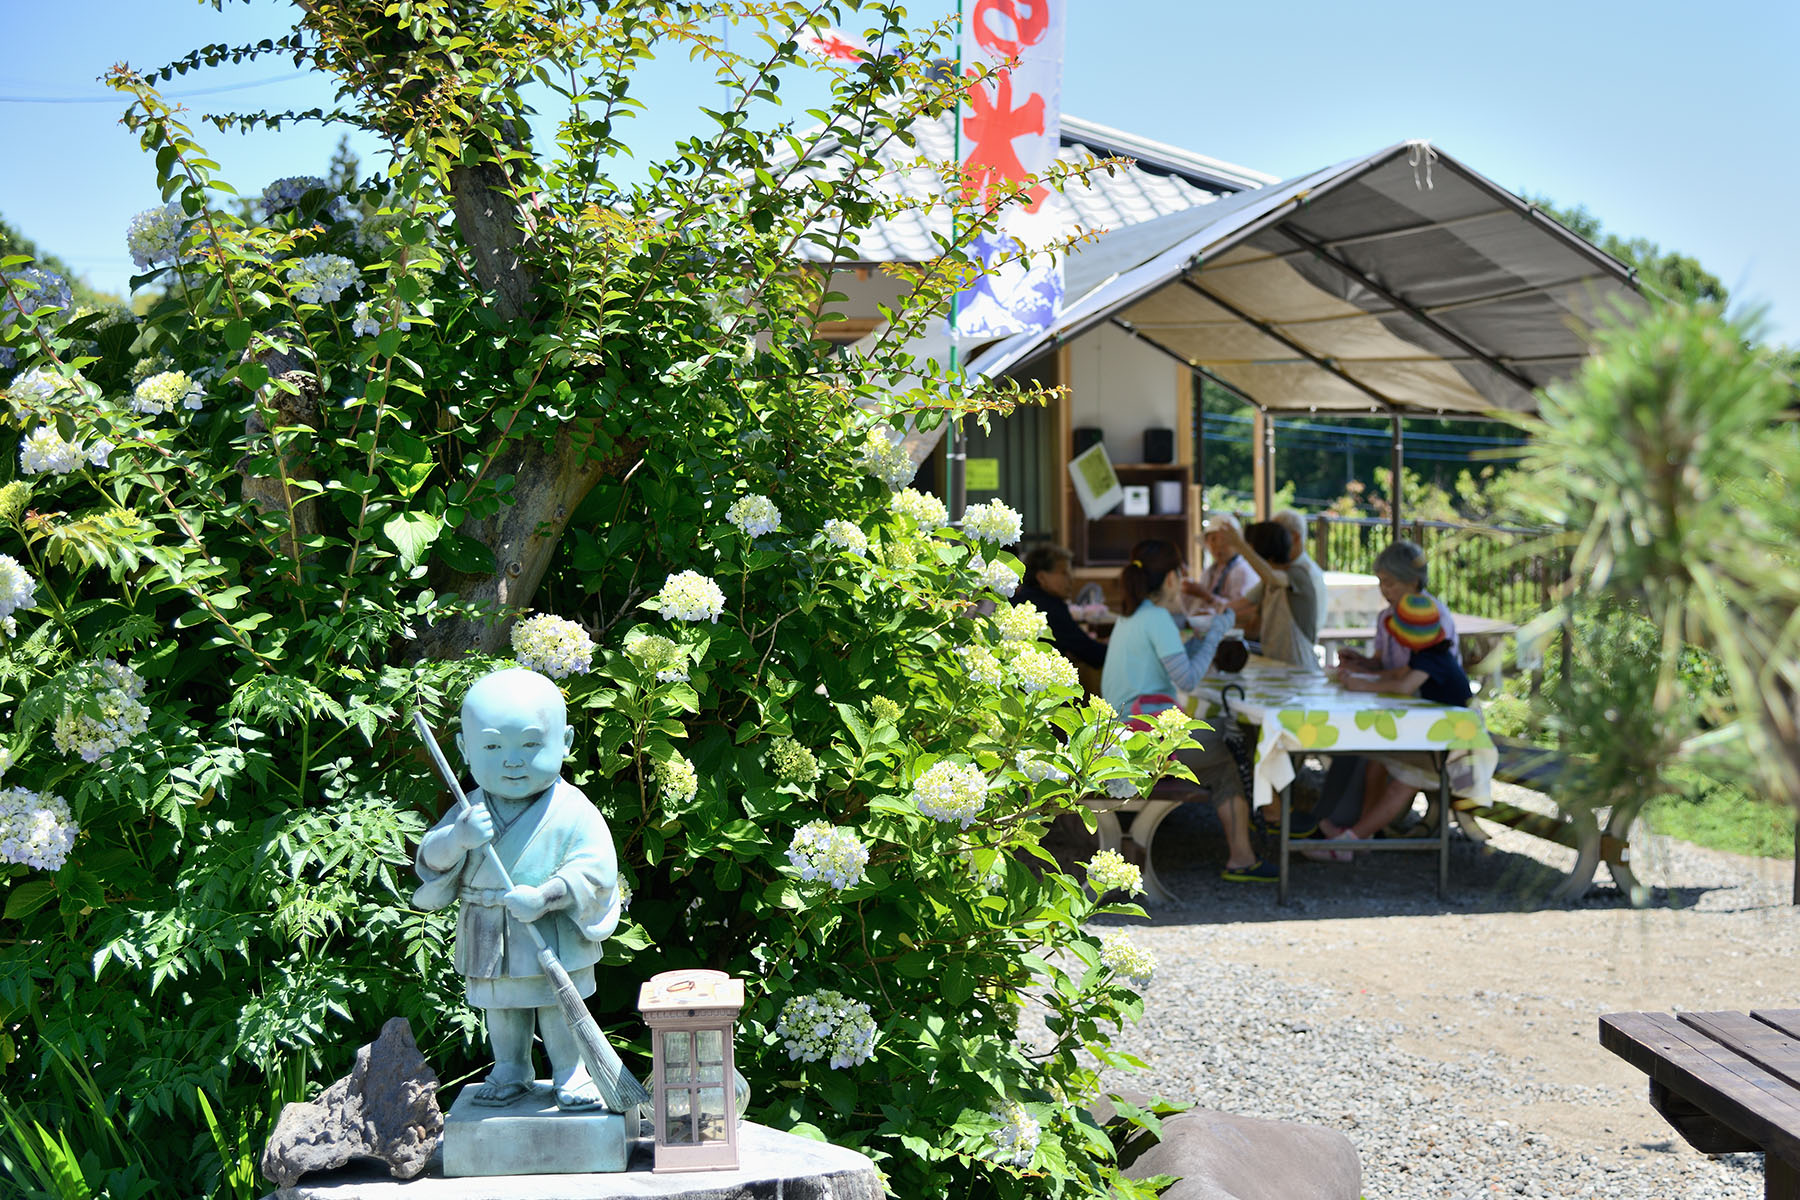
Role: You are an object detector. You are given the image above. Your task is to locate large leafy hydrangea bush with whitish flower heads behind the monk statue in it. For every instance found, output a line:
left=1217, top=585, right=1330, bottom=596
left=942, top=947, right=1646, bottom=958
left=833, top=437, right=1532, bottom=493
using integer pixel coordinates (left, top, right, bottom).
left=0, top=0, right=1179, bottom=1196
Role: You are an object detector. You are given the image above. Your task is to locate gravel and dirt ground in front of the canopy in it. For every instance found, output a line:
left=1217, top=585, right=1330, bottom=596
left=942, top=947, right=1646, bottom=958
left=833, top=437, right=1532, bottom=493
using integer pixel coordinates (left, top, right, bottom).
left=1065, top=788, right=1800, bottom=1200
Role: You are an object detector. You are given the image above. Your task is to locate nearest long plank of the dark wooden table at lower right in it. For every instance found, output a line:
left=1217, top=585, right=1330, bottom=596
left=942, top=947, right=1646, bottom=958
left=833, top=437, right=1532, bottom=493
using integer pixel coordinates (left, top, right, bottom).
left=1600, top=1013, right=1800, bottom=1162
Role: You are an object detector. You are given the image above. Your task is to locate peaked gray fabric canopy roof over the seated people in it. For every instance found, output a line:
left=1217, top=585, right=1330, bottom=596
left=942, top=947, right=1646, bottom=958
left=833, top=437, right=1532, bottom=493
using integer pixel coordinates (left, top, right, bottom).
left=970, top=142, right=1634, bottom=414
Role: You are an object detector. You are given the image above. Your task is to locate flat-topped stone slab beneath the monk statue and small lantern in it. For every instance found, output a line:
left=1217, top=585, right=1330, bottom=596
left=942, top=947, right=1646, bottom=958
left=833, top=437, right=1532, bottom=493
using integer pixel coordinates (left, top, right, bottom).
left=265, top=1110, right=886, bottom=1200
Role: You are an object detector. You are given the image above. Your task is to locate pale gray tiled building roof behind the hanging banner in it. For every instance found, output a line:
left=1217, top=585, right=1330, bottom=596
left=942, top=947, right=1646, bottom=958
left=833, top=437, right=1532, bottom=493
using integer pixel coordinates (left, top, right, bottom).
left=797, top=115, right=1274, bottom=268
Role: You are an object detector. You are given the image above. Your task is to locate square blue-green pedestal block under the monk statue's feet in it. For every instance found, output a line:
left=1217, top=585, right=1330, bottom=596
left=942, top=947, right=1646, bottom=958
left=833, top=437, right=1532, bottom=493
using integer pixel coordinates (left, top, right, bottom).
left=443, top=1083, right=637, bottom=1178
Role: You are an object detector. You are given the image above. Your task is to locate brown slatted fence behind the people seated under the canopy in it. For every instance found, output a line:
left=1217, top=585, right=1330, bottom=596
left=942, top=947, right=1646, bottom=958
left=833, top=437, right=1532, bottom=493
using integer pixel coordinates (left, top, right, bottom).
left=1307, top=513, right=1564, bottom=621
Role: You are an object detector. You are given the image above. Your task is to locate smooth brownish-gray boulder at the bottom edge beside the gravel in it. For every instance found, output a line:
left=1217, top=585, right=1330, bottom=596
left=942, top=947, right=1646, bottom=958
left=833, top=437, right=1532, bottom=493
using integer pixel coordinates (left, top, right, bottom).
left=1094, top=1092, right=1363, bottom=1200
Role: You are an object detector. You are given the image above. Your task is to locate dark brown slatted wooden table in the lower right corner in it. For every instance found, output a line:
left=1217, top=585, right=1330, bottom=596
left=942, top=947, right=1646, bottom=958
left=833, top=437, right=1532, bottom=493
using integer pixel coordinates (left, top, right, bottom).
left=1600, top=1009, right=1800, bottom=1200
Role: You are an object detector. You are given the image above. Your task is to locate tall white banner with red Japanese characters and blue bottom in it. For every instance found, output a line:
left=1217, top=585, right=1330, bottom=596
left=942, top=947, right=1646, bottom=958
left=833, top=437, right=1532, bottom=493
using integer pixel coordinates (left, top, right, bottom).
left=952, top=0, right=1071, bottom=338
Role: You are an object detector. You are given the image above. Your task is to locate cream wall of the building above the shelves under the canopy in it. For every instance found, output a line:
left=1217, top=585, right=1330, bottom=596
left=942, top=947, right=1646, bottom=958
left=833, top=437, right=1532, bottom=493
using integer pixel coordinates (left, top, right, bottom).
left=1069, top=326, right=1188, bottom=462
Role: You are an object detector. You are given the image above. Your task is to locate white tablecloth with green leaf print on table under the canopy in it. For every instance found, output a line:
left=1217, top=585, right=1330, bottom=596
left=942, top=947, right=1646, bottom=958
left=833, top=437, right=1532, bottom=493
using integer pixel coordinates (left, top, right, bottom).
left=1186, top=658, right=1499, bottom=808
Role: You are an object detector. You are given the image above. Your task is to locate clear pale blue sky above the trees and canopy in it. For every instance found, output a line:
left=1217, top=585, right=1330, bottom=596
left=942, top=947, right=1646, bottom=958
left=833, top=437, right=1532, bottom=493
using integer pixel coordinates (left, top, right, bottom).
left=0, top=0, right=1800, bottom=344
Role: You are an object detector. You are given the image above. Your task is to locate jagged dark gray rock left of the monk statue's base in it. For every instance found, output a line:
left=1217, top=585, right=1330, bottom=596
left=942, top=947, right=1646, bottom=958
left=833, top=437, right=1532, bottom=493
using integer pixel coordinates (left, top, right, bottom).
left=261, top=1016, right=445, bottom=1187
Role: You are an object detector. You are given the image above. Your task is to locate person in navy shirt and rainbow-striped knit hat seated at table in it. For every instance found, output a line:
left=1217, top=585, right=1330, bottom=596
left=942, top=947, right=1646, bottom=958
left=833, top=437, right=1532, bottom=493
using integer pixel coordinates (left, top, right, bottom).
left=1305, top=557, right=1471, bottom=862
